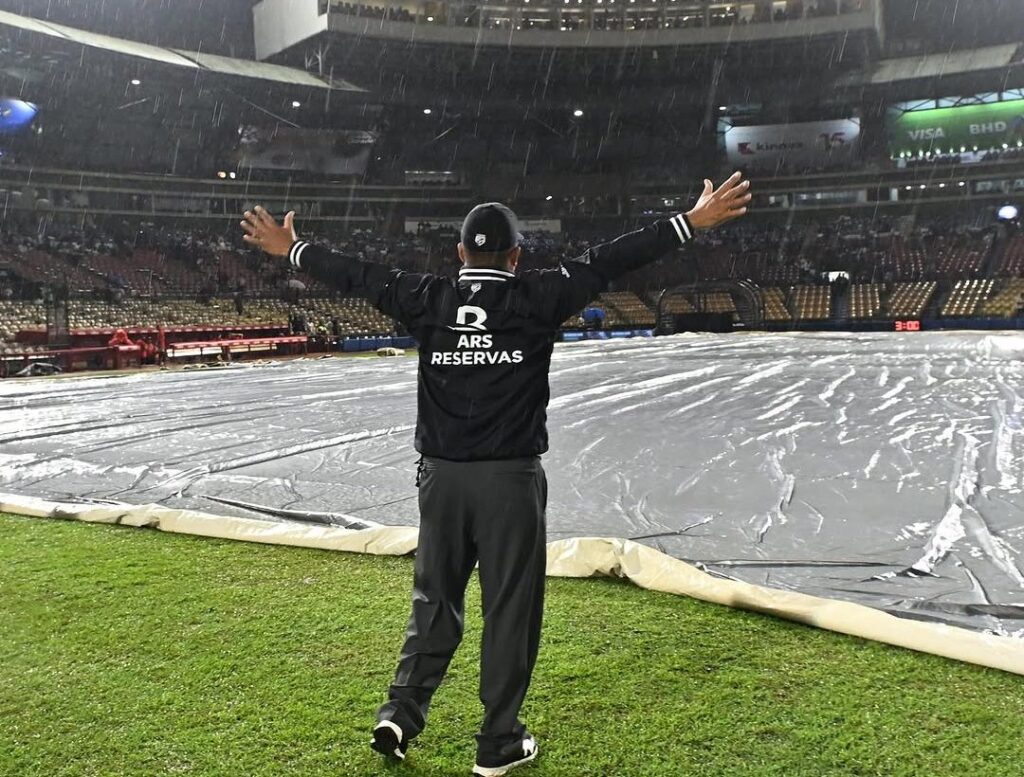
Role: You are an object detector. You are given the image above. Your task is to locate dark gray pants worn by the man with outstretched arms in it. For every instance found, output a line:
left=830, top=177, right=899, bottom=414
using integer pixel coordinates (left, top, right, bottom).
left=378, top=457, right=548, bottom=751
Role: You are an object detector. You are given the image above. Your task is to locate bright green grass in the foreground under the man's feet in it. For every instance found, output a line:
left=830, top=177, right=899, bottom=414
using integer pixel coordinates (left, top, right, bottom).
left=0, top=509, right=1024, bottom=777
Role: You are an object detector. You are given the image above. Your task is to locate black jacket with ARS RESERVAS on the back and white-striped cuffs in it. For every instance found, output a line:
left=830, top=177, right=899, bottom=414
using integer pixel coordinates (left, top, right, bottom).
left=289, top=215, right=693, bottom=461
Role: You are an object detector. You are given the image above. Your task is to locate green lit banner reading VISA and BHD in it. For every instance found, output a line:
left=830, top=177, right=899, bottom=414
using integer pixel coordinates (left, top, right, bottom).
left=886, top=99, right=1024, bottom=157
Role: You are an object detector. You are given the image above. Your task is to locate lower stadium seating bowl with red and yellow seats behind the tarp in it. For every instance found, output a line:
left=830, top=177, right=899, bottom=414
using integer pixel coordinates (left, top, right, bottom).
left=0, top=207, right=1024, bottom=356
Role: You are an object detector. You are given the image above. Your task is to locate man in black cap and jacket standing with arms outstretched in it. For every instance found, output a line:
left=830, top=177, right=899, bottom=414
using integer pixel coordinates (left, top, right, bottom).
left=242, top=173, right=751, bottom=777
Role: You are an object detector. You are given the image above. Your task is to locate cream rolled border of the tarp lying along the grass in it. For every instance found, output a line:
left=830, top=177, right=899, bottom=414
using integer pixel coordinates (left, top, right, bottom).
left=0, top=493, right=1024, bottom=675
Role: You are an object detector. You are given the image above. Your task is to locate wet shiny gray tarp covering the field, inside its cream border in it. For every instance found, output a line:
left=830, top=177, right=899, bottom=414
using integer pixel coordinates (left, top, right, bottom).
left=0, top=333, right=1024, bottom=636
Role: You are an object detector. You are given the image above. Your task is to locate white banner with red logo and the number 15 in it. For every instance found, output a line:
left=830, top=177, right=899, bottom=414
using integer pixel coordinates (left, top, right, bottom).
left=725, top=119, right=860, bottom=167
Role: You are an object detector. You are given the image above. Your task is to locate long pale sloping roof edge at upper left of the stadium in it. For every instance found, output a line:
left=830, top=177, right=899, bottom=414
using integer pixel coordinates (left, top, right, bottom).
left=0, top=11, right=365, bottom=92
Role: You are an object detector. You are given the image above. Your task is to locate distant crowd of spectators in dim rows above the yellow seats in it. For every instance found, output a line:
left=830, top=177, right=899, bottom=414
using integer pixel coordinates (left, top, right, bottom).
left=0, top=211, right=1007, bottom=312
